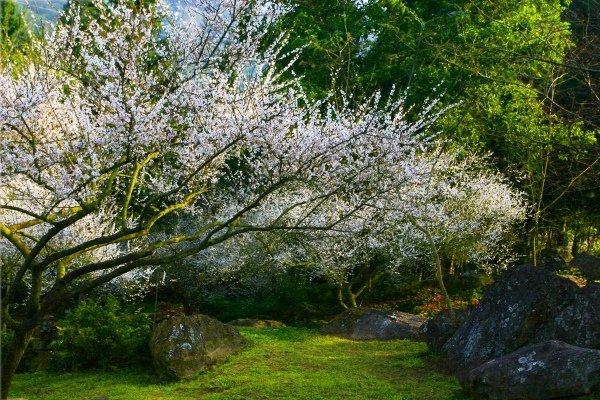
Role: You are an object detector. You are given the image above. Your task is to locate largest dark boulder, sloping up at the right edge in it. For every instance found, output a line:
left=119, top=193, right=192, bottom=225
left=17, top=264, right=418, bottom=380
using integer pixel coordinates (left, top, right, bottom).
left=442, top=265, right=600, bottom=379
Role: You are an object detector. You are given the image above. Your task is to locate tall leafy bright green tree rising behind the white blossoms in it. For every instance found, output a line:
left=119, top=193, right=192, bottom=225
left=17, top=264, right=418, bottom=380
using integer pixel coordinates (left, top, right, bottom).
left=274, top=0, right=599, bottom=262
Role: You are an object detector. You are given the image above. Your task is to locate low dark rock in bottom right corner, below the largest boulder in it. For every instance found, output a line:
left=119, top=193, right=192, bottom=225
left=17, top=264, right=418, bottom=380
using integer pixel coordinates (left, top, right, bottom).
left=463, top=340, right=600, bottom=400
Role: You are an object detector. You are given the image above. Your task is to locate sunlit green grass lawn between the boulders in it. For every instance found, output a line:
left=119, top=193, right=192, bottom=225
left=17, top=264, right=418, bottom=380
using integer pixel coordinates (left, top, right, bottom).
left=11, top=328, right=600, bottom=400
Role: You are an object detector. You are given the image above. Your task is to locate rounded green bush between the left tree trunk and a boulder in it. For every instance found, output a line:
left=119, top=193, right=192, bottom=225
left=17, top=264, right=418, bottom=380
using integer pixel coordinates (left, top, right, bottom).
left=51, top=296, right=152, bottom=370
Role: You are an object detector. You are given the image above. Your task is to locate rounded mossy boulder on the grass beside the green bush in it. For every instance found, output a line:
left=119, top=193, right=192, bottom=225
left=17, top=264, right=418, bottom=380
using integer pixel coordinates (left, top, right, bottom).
left=150, top=314, right=245, bottom=380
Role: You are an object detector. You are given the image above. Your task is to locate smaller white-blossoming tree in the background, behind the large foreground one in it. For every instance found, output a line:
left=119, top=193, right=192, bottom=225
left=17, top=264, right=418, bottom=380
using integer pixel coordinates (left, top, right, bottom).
left=180, top=148, right=527, bottom=313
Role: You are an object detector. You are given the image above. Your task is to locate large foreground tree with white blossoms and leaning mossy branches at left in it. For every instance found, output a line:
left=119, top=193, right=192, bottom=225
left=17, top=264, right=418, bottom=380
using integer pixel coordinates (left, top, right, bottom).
left=0, top=0, right=524, bottom=398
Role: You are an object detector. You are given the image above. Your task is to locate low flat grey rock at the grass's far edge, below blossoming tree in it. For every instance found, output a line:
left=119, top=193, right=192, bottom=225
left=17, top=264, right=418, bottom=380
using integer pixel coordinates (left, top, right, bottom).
left=321, top=308, right=425, bottom=340
